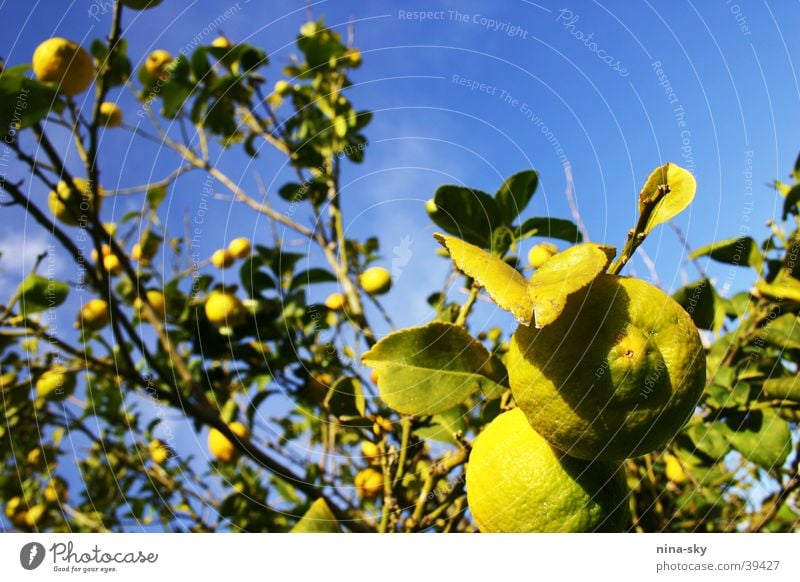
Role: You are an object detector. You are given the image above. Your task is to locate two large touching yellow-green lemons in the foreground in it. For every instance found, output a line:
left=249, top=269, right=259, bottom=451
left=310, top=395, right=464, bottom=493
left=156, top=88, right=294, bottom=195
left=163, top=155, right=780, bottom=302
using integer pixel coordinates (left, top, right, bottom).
left=466, top=244, right=705, bottom=532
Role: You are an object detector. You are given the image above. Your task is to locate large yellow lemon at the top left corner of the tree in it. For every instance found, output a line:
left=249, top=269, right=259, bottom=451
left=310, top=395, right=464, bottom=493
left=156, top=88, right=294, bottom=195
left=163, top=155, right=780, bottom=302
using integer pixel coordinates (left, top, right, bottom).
left=32, top=37, right=94, bottom=96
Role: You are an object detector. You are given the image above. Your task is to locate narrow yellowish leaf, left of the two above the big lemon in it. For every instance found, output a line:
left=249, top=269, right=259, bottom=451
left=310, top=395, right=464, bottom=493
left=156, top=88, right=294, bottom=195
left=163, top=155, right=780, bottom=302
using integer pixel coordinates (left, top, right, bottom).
left=433, top=233, right=533, bottom=325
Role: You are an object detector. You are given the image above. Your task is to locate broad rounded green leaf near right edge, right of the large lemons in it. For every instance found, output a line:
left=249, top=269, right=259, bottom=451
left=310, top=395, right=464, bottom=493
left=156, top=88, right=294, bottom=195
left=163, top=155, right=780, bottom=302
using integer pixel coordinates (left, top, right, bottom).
left=721, top=410, right=792, bottom=470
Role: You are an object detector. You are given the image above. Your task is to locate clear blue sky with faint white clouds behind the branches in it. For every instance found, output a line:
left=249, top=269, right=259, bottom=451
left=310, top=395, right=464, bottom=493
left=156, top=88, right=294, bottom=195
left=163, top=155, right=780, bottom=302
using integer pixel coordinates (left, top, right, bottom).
left=0, top=0, right=800, bottom=528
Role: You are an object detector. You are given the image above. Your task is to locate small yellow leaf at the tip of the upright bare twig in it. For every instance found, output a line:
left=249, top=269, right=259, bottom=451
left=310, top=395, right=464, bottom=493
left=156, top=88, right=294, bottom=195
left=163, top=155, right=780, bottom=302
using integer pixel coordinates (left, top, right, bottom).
left=639, top=163, right=697, bottom=234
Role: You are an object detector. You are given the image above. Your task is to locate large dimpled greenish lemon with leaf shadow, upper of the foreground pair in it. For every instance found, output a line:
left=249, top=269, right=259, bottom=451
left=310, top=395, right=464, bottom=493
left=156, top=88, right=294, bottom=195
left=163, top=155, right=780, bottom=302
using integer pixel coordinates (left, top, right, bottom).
left=507, top=275, right=706, bottom=460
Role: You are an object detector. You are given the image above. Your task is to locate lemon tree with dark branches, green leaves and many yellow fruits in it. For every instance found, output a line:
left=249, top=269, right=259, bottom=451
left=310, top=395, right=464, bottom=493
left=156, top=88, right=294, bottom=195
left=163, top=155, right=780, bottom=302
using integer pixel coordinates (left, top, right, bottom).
left=0, top=0, right=800, bottom=533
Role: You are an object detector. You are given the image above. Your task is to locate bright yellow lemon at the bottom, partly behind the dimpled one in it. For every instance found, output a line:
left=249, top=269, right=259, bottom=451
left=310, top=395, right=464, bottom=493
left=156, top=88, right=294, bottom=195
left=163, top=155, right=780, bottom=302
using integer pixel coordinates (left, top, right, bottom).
left=467, top=408, right=629, bottom=533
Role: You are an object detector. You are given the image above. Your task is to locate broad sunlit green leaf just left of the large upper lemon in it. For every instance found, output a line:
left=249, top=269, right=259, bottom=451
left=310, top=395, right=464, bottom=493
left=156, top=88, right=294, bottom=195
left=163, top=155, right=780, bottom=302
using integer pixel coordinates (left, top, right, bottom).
left=362, top=322, right=505, bottom=416
